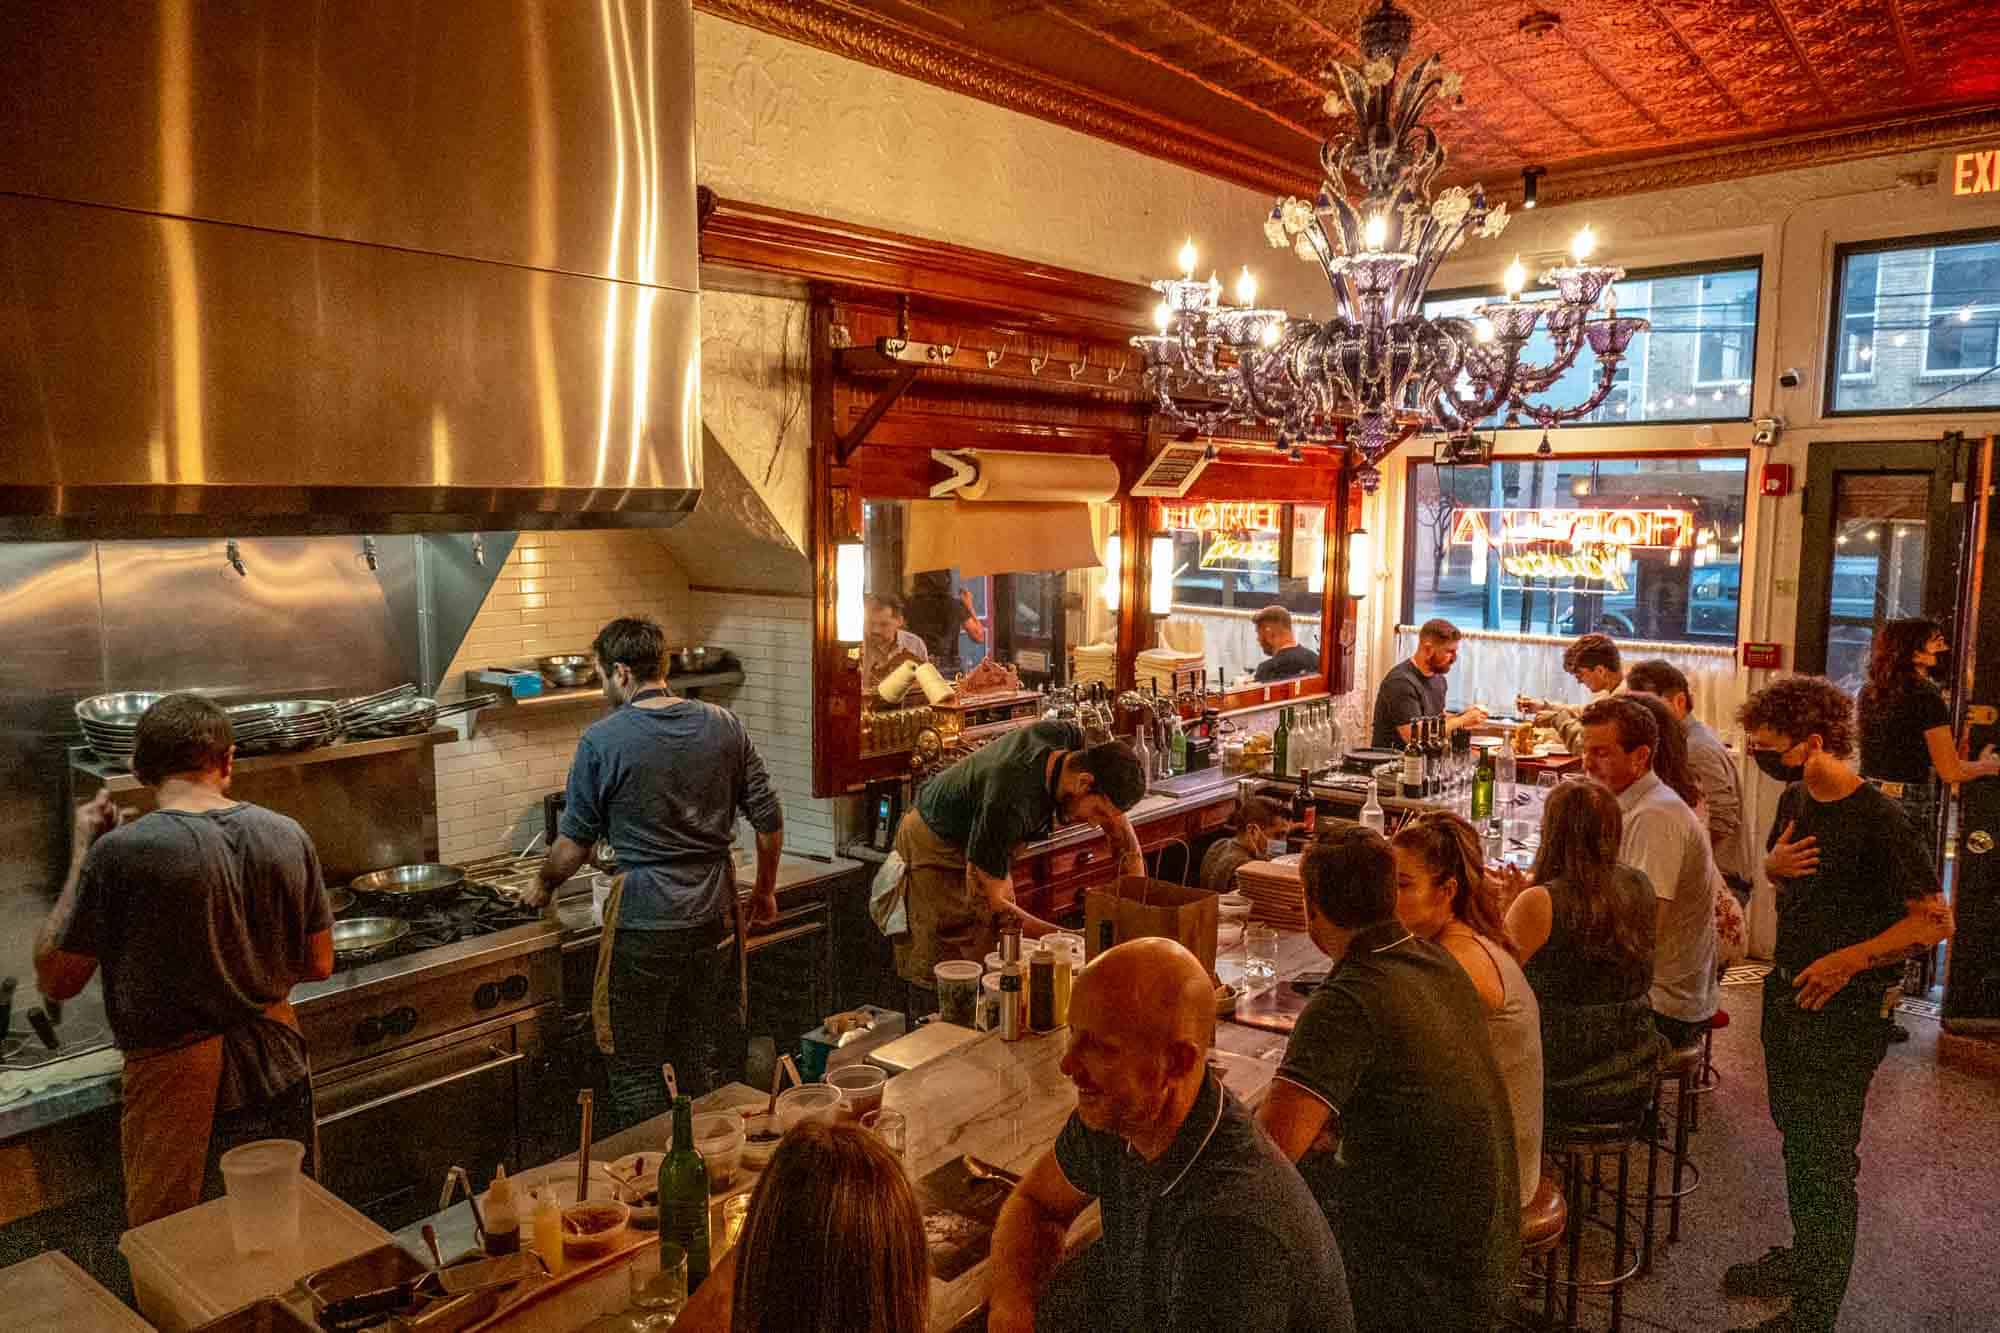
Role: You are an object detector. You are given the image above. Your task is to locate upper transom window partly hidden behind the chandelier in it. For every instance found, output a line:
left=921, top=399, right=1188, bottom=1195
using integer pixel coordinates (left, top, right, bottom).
left=1424, top=260, right=1760, bottom=426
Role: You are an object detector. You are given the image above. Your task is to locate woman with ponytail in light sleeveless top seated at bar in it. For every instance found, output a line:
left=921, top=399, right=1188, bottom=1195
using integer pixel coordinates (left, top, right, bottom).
left=1390, top=811, right=1542, bottom=1207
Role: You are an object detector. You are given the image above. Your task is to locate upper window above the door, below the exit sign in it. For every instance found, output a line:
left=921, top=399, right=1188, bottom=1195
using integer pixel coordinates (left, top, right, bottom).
left=1826, top=234, right=2000, bottom=412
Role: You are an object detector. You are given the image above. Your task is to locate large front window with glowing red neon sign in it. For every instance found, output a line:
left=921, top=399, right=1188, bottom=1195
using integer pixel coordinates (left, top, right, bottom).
left=1402, top=456, right=1748, bottom=642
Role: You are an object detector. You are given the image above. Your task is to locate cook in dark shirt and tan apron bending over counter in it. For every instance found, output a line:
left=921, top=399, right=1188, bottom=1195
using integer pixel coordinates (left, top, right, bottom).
left=896, top=723, right=1146, bottom=987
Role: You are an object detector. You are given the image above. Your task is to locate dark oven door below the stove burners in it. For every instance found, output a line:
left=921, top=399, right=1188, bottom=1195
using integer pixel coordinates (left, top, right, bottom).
left=314, top=1005, right=556, bottom=1231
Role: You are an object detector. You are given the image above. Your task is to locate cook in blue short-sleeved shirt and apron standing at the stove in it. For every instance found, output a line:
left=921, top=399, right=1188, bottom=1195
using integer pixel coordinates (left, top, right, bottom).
left=524, top=618, right=784, bottom=1125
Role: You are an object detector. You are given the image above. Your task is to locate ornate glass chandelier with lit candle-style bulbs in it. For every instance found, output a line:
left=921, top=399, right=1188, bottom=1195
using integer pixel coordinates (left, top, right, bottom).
left=1132, top=0, right=1648, bottom=490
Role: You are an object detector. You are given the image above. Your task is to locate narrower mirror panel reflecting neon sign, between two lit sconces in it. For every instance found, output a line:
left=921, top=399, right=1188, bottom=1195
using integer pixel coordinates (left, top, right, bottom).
left=1140, top=500, right=1326, bottom=689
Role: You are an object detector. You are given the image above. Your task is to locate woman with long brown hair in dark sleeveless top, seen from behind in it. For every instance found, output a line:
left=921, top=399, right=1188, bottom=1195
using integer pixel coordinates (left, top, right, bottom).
left=1506, top=779, right=1662, bottom=1125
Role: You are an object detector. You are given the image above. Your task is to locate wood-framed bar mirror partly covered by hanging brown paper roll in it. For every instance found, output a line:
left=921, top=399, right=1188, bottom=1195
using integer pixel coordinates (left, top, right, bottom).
left=862, top=500, right=1118, bottom=707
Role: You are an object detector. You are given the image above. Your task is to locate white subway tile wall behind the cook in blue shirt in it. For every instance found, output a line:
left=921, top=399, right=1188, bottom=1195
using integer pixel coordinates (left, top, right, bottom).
left=436, top=532, right=834, bottom=861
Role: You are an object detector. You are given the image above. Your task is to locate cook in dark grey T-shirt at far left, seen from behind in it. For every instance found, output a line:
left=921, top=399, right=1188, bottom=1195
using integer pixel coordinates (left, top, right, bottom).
left=34, top=695, right=334, bottom=1227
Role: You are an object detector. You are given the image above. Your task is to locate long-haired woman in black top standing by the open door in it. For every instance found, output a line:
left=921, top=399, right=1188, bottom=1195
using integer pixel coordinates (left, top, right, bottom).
left=1858, top=616, right=2000, bottom=851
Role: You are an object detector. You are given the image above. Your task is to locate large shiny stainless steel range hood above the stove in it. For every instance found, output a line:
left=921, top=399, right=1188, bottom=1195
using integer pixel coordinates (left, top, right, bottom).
left=0, top=0, right=702, bottom=538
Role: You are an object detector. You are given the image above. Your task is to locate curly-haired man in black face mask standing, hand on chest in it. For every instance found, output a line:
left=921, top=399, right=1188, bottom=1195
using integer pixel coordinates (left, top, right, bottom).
left=1722, top=677, right=1952, bottom=1333
